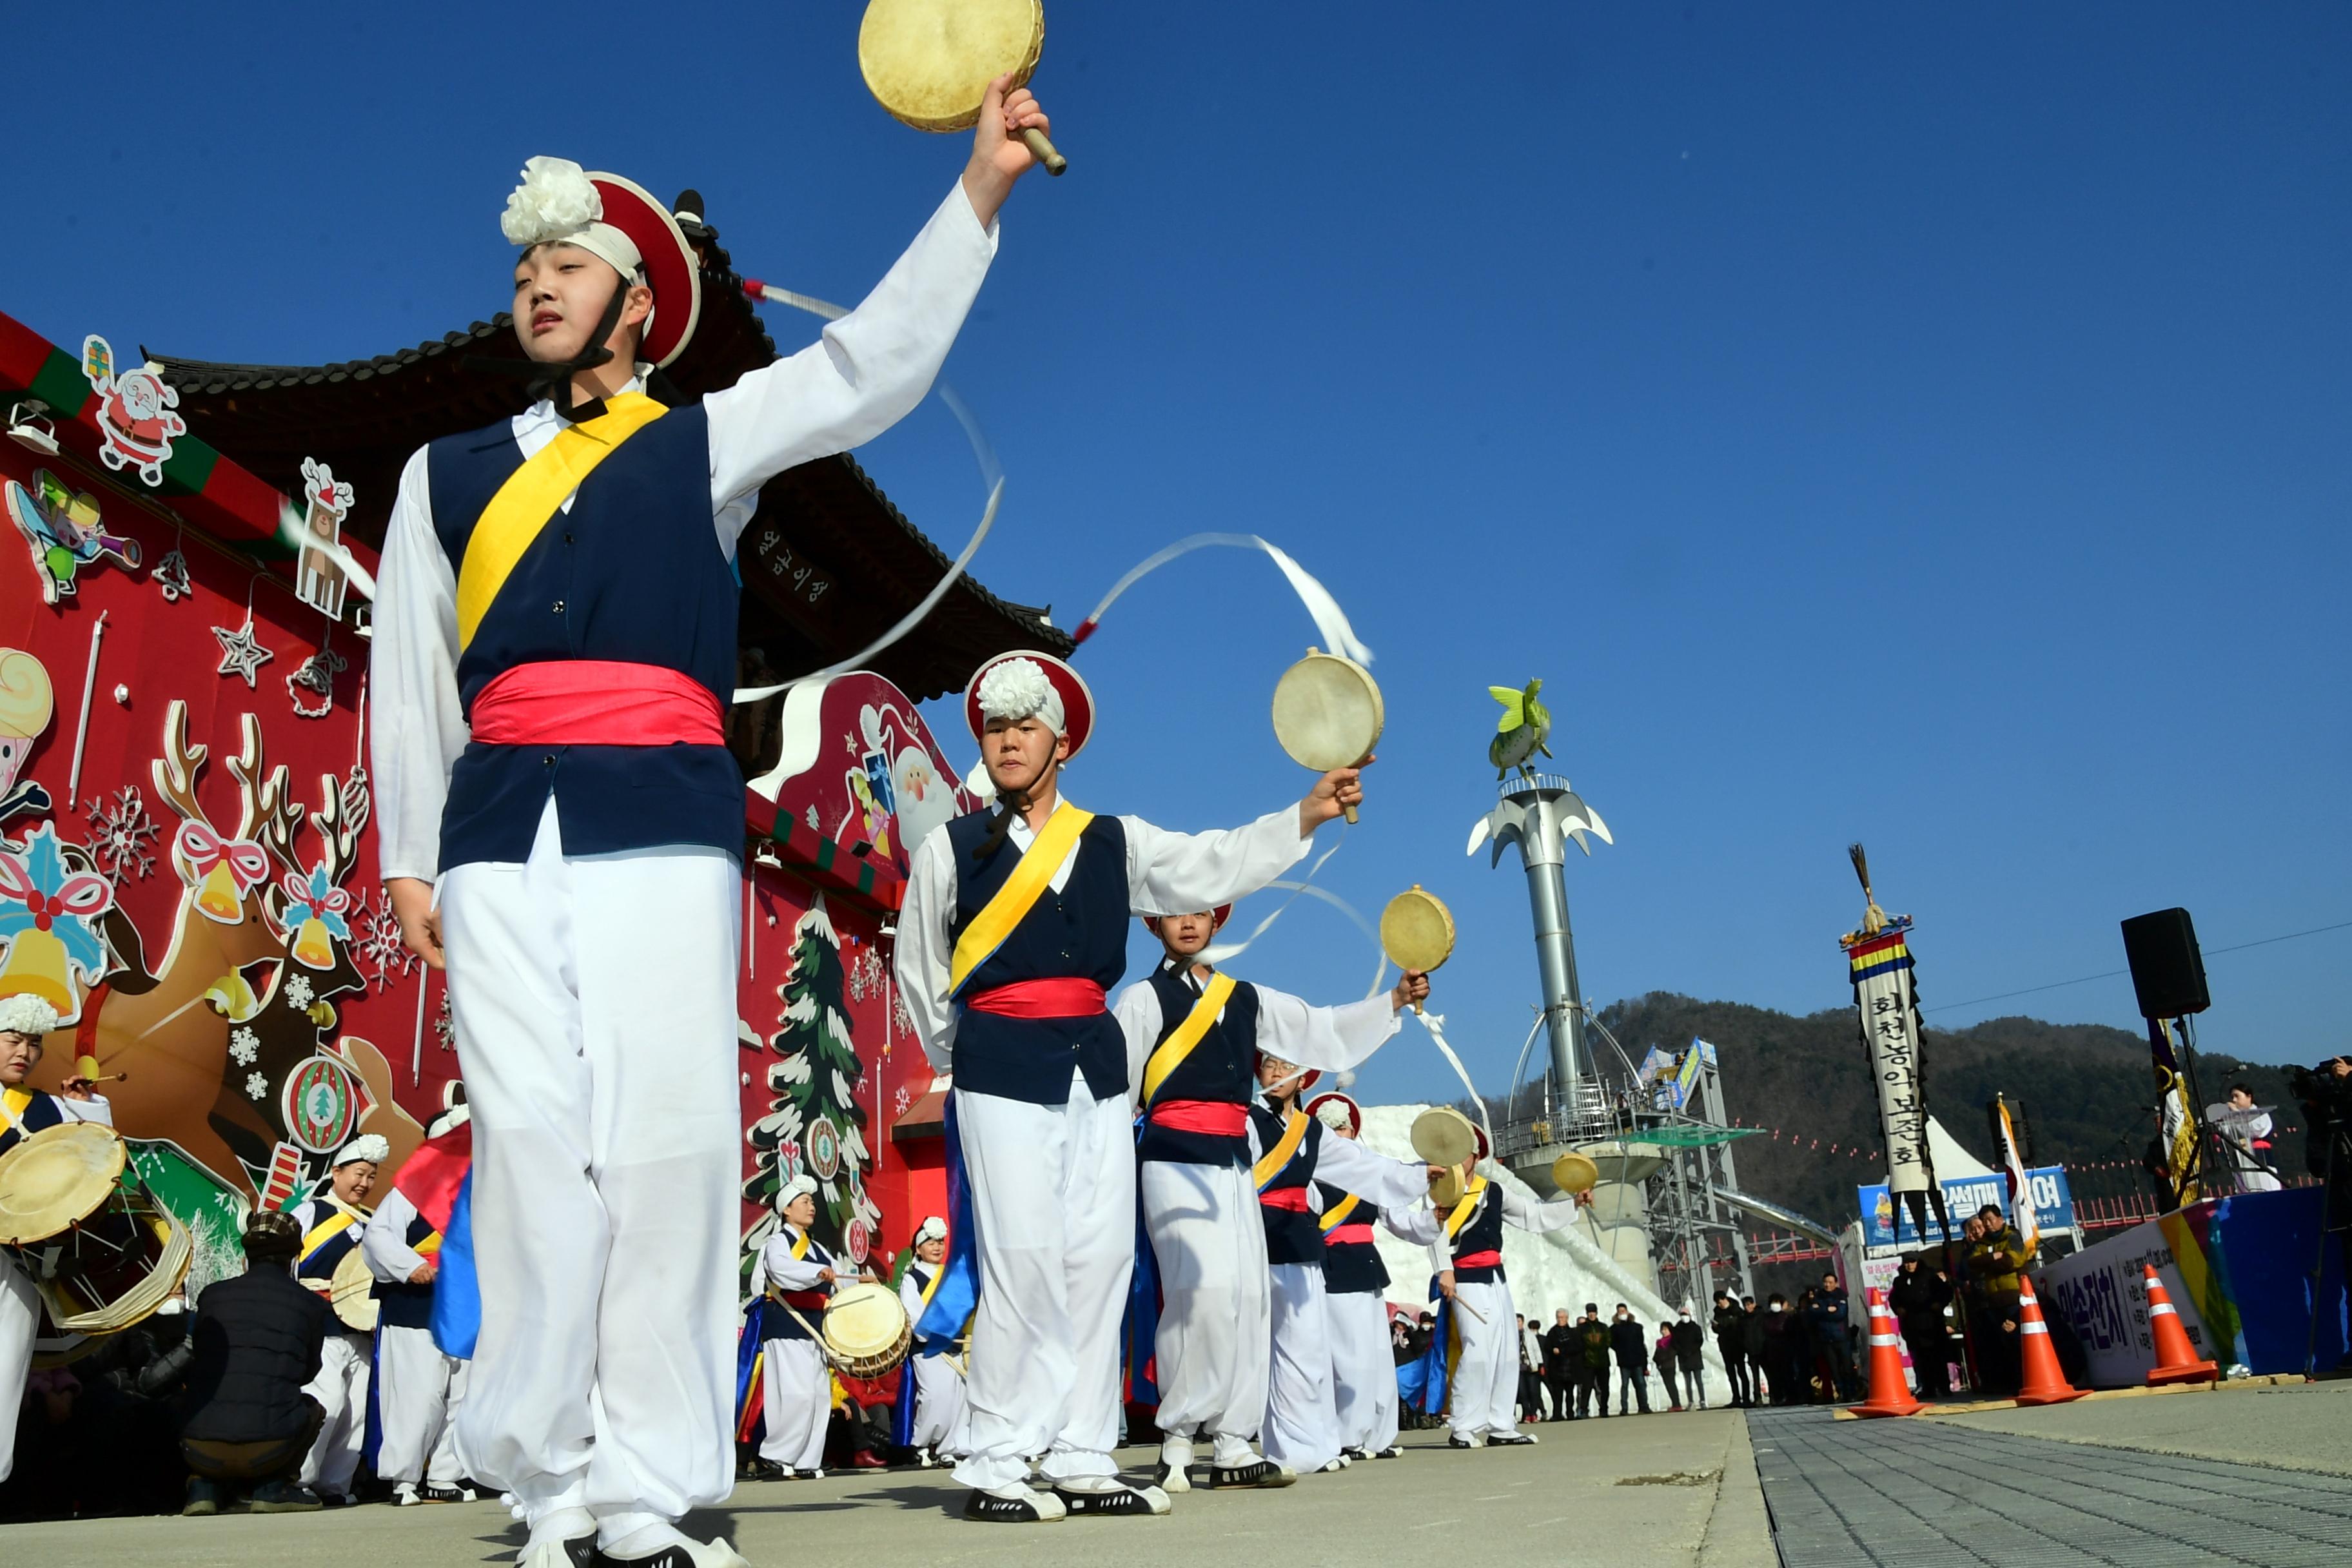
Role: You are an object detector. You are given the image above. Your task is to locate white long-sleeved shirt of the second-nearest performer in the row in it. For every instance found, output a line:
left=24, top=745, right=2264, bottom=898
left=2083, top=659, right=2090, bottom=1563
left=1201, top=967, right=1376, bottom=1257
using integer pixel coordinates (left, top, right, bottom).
left=892, top=807, right=1313, bottom=1077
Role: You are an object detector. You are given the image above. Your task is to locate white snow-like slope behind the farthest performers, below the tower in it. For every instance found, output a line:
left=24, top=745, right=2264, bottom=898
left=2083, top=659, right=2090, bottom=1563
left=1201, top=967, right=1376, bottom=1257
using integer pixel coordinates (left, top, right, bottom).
left=1364, top=1105, right=1731, bottom=1404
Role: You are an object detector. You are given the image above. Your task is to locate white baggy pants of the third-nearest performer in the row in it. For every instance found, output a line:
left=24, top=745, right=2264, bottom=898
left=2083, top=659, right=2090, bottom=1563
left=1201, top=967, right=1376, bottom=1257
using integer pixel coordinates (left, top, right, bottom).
left=1136, top=1159, right=1273, bottom=1465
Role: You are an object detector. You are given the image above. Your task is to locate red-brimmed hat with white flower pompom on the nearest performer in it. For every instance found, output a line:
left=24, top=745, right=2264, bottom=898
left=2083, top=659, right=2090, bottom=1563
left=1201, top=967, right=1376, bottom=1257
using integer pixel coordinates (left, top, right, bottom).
left=498, top=157, right=703, bottom=364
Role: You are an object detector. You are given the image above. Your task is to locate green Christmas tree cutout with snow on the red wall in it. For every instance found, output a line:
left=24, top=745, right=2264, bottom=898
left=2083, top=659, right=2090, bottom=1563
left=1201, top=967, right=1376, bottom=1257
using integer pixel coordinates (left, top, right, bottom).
left=743, top=894, right=882, bottom=1279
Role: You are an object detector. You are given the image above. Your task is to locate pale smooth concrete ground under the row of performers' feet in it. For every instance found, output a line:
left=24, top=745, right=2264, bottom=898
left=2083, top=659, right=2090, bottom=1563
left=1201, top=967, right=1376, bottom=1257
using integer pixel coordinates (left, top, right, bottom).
left=0, top=1411, right=1776, bottom=1568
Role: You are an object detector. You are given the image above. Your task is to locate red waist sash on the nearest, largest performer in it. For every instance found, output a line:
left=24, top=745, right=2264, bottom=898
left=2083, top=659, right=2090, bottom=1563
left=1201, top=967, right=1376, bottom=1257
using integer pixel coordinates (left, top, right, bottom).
left=468, top=658, right=727, bottom=745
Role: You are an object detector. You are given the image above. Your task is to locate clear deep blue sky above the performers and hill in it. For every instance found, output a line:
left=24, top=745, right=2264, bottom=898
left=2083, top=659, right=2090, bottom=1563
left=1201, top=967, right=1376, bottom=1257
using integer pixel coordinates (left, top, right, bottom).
left=0, top=0, right=2352, bottom=1098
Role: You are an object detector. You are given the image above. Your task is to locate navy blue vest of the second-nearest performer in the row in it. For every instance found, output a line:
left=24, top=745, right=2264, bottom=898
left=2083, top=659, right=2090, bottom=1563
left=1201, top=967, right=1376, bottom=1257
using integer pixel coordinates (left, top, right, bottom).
left=945, top=808, right=1129, bottom=1105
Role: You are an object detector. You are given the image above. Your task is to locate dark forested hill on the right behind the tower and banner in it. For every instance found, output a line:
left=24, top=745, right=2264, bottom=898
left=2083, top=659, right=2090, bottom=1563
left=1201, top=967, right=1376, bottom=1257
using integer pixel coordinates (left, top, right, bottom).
left=1602, top=992, right=2302, bottom=1227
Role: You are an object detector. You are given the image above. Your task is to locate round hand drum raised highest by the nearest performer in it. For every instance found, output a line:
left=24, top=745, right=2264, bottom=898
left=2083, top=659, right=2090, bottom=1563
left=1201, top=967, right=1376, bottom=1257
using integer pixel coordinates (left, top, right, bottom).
left=859, top=0, right=1070, bottom=174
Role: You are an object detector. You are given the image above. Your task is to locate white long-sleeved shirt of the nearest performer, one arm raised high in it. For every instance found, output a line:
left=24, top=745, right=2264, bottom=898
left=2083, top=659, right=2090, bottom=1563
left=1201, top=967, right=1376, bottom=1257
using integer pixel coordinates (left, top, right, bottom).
left=369, top=186, right=997, bottom=881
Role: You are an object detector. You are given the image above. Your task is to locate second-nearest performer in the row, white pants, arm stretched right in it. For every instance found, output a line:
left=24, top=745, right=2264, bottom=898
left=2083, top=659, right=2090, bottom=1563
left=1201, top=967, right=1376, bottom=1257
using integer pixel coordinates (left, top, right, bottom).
left=896, top=654, right=1362, bottom=1521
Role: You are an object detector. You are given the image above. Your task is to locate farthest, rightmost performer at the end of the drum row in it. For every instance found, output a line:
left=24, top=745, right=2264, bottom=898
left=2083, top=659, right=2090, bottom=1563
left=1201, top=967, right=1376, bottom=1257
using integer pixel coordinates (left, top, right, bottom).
left=1395, top=1128, right=1576, bottom=1448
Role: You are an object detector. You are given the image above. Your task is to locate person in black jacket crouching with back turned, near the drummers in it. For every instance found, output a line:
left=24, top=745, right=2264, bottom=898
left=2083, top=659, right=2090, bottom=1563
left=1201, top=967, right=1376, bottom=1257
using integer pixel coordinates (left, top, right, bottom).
left=179, top=1211, right=329, bottom=1514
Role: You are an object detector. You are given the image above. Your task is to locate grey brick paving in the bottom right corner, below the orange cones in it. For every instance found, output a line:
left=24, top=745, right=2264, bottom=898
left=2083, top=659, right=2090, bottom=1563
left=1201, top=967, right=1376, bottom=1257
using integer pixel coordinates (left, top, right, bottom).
left=1750, top=1385, right=2352, bottom=1568
